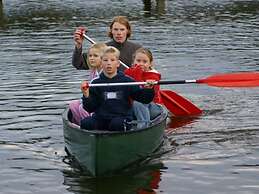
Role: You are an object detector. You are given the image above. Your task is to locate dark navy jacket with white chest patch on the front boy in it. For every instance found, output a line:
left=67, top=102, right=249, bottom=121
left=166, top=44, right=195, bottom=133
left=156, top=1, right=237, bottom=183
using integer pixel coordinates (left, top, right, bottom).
left=82, top=71, right=155, bottom=120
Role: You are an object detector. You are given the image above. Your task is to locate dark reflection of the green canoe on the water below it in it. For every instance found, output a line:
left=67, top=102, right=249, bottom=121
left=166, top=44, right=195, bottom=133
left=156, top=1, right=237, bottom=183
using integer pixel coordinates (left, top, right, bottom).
left=63, top=163, right=163, bottom=194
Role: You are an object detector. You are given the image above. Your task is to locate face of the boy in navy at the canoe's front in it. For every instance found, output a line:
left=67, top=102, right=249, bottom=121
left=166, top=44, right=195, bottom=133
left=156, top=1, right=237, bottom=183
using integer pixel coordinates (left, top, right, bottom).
left=102, top=53, right=120, bottom=77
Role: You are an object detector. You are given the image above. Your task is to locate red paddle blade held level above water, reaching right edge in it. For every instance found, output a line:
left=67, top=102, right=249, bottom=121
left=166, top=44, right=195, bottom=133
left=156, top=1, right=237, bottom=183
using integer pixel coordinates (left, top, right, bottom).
left=197, top=72, right=259, bottom=87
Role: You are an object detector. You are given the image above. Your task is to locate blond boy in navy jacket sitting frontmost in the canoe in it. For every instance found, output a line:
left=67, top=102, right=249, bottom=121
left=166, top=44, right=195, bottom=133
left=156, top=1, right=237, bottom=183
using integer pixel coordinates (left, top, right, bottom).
left=80, top=46, right=154, bottom=131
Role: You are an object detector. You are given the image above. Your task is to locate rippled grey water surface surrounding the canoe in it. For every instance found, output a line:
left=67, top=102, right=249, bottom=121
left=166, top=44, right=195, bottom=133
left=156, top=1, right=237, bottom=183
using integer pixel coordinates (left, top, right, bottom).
left=0, top=0, right=259, bottom=194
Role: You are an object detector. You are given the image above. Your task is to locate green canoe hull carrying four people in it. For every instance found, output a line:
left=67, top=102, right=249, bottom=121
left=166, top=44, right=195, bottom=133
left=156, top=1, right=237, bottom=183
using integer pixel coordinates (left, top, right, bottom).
left=62, top=106, right=168, bottom=177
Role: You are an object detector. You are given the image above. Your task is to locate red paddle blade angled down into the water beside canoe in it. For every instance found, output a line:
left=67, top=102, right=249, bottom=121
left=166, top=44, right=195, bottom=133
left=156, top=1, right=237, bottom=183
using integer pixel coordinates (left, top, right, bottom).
left=160, top=90, right=202, bottom=117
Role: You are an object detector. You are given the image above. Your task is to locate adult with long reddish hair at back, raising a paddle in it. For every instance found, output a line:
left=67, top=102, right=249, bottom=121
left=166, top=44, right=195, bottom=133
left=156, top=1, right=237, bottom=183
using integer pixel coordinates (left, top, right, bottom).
left=72, top=16, right=141, bottom=70
